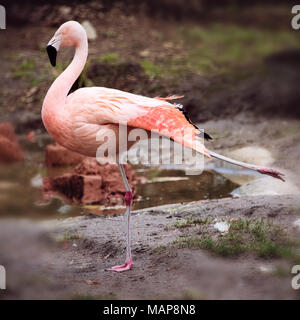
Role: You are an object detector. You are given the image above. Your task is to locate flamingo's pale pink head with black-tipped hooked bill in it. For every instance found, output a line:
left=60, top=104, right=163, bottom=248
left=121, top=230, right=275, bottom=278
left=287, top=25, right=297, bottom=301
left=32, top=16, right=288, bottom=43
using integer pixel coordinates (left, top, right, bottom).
left=47, top=21, right=87, bottom=67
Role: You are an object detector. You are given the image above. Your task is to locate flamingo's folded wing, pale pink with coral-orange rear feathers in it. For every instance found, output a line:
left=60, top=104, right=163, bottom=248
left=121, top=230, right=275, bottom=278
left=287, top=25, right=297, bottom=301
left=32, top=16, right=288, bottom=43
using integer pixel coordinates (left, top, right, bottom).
left=67, top=87, right=210, bottom=157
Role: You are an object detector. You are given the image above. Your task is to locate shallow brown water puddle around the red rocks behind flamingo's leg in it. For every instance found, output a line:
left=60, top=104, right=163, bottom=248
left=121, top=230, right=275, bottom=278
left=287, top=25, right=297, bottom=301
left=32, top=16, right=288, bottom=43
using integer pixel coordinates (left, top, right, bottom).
left=0, top=146, right=244, bottom=219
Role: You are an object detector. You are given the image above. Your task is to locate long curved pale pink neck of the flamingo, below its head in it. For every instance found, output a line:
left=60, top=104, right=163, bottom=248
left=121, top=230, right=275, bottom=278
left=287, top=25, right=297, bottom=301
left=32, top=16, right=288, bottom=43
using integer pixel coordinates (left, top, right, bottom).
left=43, top=35, right=88, bottom=109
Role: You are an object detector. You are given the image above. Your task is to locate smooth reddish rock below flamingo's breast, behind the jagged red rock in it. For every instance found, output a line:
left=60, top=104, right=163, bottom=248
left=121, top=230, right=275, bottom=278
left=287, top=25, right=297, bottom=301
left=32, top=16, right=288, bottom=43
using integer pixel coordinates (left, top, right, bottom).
left=45, top=143, right=85, bottom=167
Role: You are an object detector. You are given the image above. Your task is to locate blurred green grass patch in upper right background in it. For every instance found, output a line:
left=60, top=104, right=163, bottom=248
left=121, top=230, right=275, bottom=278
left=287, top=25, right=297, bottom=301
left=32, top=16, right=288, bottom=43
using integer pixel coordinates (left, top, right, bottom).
left=142, top=24, right=300, bottom=78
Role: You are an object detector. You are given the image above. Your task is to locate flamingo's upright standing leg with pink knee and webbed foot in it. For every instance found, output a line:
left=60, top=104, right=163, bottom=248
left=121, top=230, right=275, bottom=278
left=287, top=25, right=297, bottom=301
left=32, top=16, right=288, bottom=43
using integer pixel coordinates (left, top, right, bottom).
left=108, top=164, right=133, bottom=272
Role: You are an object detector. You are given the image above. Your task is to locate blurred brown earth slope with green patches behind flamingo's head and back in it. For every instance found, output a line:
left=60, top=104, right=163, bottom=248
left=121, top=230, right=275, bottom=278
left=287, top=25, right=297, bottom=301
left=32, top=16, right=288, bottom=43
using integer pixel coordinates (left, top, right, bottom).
left=1, top=0, right=299, bottom=124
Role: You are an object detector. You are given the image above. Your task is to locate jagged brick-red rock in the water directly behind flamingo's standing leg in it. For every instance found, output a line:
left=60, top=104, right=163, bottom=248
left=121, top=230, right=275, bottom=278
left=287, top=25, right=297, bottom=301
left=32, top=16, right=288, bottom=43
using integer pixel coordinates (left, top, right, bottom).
left=43, top=158, right=137, bottom=205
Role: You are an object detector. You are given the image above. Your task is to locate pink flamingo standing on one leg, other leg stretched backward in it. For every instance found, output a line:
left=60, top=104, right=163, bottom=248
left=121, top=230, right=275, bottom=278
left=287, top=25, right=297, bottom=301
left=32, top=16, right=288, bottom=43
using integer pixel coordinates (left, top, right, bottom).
left=42, top=21, right=284, bottom=272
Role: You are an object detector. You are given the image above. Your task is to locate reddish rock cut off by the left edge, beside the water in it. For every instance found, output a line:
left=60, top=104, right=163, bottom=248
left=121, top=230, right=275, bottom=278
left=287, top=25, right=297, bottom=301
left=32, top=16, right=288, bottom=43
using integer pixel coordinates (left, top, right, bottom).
left=0, top=123, right=24, bottom=162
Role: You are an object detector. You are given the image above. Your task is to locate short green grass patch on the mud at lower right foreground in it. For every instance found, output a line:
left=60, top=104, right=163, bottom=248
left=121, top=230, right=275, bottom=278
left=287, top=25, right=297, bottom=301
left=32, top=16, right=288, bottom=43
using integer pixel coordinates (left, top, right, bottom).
left=176, top=219, right=300, bottom=261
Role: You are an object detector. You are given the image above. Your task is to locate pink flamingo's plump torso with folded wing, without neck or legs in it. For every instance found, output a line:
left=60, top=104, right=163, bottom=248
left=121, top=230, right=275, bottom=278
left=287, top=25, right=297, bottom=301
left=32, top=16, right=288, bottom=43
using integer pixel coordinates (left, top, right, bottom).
left=42, top=87, right=209, bottom=157
